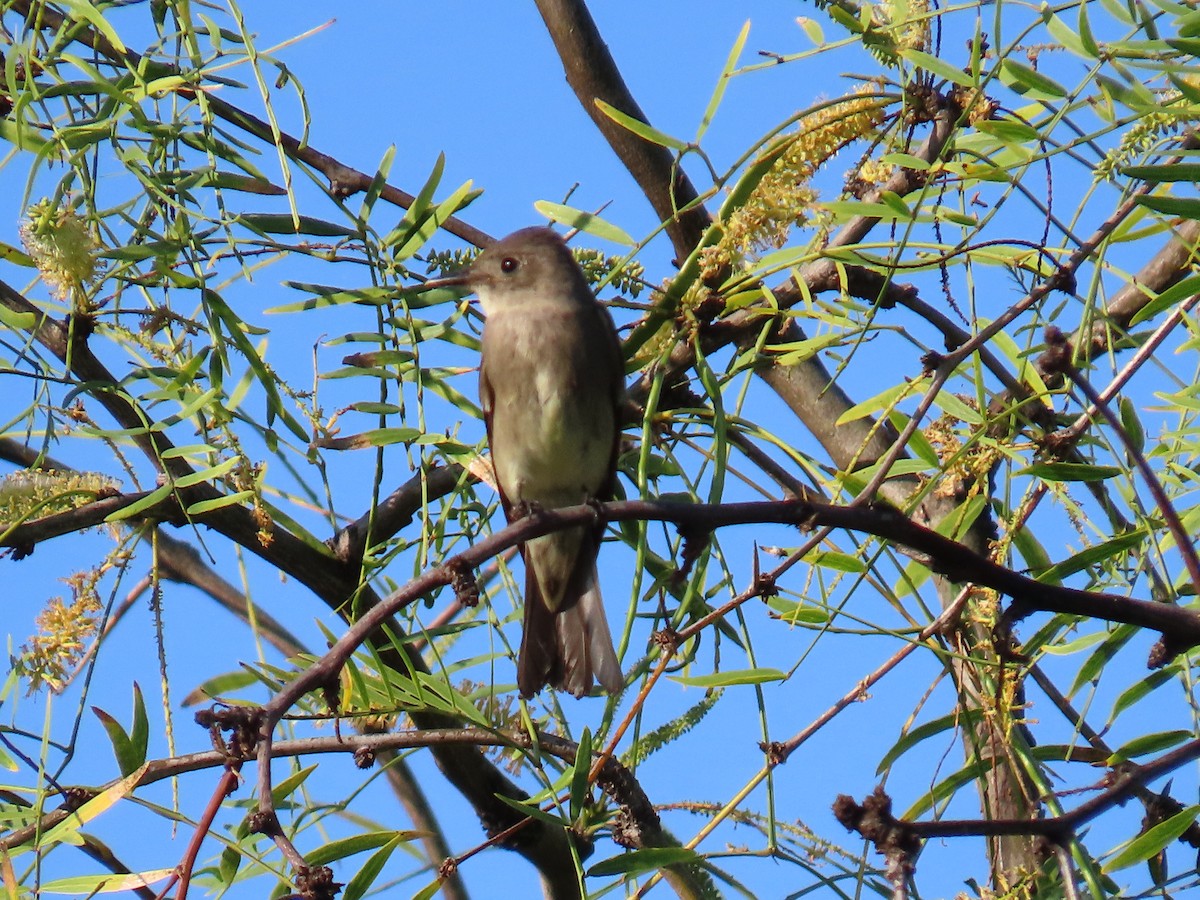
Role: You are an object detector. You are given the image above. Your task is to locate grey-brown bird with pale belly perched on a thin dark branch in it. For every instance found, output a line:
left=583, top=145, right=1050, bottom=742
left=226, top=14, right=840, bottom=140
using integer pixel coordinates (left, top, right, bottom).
left=463, top=228, right=625, bottom=697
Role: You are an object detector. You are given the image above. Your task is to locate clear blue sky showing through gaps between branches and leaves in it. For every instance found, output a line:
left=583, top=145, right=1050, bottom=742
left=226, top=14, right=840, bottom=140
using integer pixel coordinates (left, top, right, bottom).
left=0, top=2, right=1195, bottom=896
